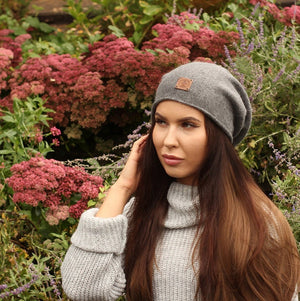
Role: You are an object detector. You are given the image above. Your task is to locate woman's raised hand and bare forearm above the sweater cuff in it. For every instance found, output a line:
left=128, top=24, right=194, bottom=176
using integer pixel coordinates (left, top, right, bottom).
left=96, top=135, right=148, bottom=218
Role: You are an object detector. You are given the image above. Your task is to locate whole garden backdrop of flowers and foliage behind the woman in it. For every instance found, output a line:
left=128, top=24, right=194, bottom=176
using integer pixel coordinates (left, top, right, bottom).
left=0, top=0, right=300, bottom=300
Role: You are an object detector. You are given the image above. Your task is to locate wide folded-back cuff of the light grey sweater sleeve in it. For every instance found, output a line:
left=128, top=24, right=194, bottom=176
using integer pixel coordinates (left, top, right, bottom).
left=71, top=208, right=128, bottom=254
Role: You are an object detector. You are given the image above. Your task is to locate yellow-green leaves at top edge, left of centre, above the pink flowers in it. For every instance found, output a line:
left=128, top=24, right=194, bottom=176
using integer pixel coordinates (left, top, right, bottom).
left=65, top=0, right=189, bottom=48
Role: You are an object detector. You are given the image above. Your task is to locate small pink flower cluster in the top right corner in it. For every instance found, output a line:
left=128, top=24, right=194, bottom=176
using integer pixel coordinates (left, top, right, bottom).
left=249, top=0, right=300, bottom=26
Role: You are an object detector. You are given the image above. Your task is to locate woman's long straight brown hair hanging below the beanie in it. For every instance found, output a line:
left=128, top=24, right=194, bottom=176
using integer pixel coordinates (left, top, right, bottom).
left=125, top=117, right=300, bottom=301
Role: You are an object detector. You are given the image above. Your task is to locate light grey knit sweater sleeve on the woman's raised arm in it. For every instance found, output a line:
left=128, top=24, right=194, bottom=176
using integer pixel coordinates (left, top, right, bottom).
left=61, top=204, right=128, bottom=301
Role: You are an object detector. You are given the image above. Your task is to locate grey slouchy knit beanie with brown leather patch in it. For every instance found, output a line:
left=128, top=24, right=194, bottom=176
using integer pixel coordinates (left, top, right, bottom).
left=152, top=62, right=251, bottom=145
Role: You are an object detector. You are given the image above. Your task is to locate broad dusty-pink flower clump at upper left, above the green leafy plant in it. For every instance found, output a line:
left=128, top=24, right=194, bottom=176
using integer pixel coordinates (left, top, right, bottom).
left=3, top=54, right=87, bottom=126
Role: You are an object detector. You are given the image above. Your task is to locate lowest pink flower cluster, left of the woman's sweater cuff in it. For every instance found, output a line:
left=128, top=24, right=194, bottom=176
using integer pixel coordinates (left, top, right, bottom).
left=7, top=157, right=103, bottom=224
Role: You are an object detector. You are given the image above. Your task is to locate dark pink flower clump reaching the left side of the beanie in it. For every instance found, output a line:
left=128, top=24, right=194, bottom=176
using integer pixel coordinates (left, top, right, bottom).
left=83, top=35, right=187, bottom=104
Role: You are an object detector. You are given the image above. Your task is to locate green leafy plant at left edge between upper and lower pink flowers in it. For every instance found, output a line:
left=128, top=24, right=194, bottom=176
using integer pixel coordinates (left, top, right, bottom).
left=0, top=97, right=53, bottom=206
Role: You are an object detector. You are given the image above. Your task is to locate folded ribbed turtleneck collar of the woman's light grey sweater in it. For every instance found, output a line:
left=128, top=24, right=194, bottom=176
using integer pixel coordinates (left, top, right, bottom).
left=165, top=182, right=197, bottom=229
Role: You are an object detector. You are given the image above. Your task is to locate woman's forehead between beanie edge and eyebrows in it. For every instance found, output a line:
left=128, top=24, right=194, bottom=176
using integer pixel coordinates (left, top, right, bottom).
left=155, top=100, right=204, bottom=119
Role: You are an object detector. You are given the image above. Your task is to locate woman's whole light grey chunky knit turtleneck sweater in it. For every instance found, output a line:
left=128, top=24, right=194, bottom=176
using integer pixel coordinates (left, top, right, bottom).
left=61, top=182, right=298, bottom=301
